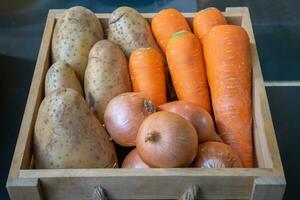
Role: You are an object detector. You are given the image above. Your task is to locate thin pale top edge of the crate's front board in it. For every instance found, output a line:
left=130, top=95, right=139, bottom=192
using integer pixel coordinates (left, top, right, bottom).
left=20, top=168, right=273, bottom=178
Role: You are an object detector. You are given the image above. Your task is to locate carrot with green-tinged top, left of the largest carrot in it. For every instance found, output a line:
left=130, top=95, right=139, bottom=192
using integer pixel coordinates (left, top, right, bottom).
left=166, top=31, right=211, bottom=113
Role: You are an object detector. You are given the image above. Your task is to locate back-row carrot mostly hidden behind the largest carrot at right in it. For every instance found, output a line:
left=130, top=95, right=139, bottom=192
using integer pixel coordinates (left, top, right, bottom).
left=193, top=7, right=227, bottom=43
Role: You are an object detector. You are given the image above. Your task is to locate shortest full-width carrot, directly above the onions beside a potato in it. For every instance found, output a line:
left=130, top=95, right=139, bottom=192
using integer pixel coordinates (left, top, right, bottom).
left=129, top=48, right=167, bottom=106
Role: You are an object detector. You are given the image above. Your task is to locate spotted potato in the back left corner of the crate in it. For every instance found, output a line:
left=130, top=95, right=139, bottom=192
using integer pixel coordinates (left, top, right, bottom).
left=52, top=6, right=104, bottom=83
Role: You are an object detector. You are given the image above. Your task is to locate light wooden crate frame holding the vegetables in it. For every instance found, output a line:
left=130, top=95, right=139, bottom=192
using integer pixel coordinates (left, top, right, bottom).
left=6, top=7, right=286, bottom=200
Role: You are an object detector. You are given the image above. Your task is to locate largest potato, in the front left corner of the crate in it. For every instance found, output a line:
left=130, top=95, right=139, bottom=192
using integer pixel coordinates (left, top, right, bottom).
left=33, top=88, right=117, bottom=169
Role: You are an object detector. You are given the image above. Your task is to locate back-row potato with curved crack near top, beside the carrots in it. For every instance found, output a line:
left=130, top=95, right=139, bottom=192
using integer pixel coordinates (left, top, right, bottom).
left=107, top=7, right=163, bottom=58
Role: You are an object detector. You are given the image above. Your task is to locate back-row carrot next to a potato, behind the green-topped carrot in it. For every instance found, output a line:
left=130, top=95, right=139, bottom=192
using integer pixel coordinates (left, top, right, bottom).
left=151, top=8, right=191, bottom=53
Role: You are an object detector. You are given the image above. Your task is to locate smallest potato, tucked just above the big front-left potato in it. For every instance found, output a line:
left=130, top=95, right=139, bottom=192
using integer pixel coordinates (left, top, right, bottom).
left=45, top=61, right=82, bottom=96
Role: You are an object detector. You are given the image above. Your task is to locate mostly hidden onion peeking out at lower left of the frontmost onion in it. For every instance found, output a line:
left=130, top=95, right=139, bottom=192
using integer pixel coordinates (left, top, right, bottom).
left=122, top=149, right=149, bottom=168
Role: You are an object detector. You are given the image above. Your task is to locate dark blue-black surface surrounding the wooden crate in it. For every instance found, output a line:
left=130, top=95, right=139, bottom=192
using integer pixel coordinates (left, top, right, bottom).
left=0, top=0, right=300, bottom=199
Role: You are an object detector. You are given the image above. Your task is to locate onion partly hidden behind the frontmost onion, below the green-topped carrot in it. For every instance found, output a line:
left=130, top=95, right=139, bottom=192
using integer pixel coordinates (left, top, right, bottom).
left=159, top=101, right=222, bottom=143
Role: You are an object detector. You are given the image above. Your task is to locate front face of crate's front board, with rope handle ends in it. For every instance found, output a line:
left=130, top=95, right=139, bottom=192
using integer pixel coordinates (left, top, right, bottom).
left=41, top=175, right=253, bottom=200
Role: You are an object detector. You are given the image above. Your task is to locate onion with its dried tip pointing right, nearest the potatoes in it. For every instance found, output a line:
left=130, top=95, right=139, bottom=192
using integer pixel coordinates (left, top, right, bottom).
left=104, top=92, right=155, bottom=146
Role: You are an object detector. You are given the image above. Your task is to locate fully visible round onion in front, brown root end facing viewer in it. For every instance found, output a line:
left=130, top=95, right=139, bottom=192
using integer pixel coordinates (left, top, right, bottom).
left=136, top=111, right=198, bottom=168
